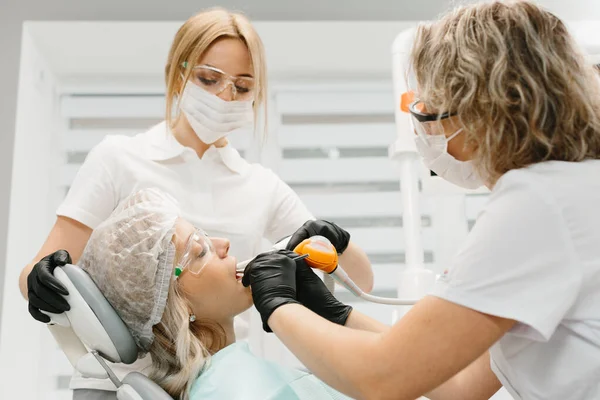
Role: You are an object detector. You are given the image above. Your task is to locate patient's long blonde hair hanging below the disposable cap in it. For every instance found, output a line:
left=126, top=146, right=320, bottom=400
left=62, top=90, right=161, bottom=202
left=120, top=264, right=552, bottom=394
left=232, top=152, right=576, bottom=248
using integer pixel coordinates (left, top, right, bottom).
left=149, top=281, right=225, bottom=400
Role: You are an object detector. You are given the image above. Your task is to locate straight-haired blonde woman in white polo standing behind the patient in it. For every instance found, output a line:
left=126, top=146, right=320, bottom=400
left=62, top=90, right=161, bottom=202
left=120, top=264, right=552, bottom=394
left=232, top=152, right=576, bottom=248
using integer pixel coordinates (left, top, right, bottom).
left=20, top=9, right=373, bottom=399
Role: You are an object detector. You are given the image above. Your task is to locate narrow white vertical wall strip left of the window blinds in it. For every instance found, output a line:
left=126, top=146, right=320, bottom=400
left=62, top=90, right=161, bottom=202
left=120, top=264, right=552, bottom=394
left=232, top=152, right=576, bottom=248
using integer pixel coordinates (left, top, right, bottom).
left=0, top=26, right=61, bottom=399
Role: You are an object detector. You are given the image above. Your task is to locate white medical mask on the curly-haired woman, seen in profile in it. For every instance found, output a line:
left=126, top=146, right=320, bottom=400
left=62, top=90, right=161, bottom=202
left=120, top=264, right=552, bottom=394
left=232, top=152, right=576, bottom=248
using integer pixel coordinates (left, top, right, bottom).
left=415, top=129, right=484, bottom=189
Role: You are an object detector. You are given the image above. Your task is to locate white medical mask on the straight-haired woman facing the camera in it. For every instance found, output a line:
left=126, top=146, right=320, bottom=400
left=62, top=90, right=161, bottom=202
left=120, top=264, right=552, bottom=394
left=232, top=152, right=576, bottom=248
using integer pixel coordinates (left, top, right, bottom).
left=179, top=81, right=254, bottom=144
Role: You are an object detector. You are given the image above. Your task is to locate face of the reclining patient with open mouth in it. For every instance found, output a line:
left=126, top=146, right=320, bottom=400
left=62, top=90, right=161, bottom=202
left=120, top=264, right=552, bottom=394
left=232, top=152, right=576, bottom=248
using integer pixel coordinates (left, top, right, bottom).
left=175, top=219, right=252, bottom=322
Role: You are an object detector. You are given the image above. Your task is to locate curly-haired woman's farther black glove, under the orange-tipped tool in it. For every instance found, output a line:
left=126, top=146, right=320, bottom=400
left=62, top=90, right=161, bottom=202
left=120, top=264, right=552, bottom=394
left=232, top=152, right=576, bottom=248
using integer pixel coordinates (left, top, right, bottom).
left=290, top=252, right=352, bottom=325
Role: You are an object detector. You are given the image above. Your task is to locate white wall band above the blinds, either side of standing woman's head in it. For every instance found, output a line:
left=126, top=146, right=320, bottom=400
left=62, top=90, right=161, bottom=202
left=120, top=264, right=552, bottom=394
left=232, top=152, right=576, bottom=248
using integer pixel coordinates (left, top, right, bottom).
left=24, top=21, right=415, bottom=85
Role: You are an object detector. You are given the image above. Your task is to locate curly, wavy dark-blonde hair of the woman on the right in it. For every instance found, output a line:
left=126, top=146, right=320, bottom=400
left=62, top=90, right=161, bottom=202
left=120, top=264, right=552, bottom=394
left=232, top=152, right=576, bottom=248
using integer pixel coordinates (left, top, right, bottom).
left=410, top=1, right=600, bottom=184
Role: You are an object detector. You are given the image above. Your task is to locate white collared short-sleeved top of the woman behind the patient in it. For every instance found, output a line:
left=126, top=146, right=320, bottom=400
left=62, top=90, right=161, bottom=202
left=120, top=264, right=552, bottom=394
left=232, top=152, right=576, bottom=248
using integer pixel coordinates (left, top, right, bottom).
left=57, top=122, right=313, bottom=390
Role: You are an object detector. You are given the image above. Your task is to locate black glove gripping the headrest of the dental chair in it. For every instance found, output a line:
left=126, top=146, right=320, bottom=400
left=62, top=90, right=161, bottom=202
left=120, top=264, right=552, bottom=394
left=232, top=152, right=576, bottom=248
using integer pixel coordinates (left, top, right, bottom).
left=27, top=250, right=71, bottom=323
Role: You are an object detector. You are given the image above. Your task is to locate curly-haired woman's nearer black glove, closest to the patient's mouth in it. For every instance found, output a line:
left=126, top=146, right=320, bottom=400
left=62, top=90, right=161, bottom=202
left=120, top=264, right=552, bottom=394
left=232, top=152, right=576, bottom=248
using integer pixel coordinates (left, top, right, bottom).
left=242, top=252, right=298, bottom=332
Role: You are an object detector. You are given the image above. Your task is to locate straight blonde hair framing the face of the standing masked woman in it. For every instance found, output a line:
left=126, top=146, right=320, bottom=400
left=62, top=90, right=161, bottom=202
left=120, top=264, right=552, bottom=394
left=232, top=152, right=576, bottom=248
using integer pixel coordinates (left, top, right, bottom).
left=165, top=8, right=267, bottom=134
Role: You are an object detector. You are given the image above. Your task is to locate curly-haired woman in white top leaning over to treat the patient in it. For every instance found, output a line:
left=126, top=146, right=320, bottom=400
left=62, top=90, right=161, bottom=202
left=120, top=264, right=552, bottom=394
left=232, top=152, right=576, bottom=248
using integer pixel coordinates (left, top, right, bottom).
left=244, top=1, right=600, bottom=400
